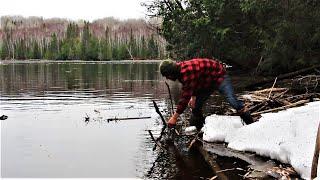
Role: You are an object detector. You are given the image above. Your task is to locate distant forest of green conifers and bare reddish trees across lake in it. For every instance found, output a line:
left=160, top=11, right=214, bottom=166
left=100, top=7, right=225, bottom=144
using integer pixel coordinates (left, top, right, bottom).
left=0, top=16, right=165, bottom=60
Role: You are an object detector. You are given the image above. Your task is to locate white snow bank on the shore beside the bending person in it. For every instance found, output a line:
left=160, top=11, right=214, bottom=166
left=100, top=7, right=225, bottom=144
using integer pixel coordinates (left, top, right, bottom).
left=203, top=101, right=320, bottom=179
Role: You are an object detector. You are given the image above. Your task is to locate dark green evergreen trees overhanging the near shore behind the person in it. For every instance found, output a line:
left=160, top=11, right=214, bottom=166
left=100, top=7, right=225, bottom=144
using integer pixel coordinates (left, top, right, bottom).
left=145, top=0, right=320, bottom=74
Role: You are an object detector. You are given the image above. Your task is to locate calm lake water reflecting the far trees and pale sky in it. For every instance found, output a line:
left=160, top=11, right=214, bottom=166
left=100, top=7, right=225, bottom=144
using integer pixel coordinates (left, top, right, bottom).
left=0, top=61, right=248, bottom=179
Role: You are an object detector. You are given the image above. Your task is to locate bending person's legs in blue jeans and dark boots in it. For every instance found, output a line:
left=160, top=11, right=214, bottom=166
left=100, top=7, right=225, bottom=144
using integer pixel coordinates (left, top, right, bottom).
left=190, top=75, right=252, bottom=130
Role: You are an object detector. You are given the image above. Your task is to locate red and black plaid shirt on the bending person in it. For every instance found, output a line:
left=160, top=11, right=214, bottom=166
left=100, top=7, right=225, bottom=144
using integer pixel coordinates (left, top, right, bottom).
left=177, top=59, right=226, bottom=114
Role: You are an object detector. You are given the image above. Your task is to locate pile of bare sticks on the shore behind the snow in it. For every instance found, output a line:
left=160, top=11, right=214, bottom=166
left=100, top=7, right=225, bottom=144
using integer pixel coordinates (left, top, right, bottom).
left=241, top=87, right=320, bottom=116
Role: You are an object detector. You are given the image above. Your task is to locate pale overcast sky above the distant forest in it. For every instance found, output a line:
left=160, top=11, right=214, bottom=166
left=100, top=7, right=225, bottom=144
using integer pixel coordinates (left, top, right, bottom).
left=0, top=0, right=146, bottom=21
